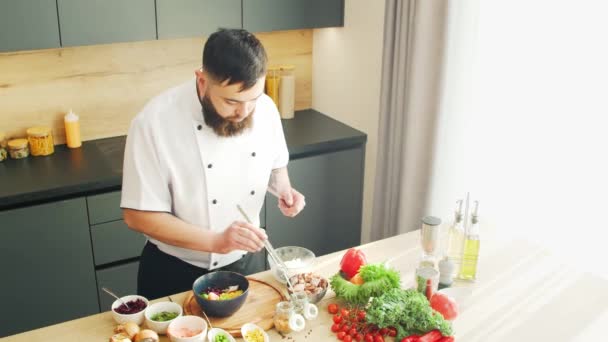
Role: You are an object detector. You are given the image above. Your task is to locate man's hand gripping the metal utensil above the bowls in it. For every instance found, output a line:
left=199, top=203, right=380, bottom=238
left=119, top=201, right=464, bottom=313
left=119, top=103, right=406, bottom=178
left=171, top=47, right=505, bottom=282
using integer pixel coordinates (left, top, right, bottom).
left=214, top=221, right=268, bottom=254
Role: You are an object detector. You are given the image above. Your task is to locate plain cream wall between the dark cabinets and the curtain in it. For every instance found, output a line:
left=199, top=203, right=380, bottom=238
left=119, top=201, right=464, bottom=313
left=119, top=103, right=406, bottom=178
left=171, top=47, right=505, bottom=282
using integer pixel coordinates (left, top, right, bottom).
left=312, top=0, right=384, bottom=242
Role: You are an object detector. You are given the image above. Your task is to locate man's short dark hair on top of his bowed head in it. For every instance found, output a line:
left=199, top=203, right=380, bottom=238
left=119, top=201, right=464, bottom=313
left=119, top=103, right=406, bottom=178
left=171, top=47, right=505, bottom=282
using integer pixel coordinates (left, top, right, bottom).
left=203, top=29, right=267, bottom=91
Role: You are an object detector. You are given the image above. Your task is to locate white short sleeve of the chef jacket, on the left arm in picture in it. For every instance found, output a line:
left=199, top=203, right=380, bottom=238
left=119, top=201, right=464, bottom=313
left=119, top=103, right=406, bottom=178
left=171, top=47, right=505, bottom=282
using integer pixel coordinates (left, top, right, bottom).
left=120, top=115, right=171, bottom=212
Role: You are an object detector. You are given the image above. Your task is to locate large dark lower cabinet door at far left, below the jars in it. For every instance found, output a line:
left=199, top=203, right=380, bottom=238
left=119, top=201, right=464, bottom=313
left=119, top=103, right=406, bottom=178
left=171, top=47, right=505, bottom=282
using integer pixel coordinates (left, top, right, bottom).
left=0, top=198, right=99, bottom=337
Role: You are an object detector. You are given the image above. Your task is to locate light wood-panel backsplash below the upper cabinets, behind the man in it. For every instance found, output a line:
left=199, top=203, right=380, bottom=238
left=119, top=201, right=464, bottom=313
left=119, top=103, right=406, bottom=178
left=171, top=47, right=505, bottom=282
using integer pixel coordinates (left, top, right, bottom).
left=0, top=30, right=312, bottom=144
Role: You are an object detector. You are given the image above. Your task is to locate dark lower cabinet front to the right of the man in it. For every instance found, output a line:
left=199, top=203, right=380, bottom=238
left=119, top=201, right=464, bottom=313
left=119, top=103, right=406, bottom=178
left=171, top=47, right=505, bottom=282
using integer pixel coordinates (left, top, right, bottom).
left=266, top=145, right=365, bottom=255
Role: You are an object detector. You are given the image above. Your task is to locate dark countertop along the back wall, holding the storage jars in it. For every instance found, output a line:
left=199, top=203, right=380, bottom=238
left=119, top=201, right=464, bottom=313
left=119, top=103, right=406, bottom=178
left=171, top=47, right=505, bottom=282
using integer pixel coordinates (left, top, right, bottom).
left=0, top=109, right=367, bottom=210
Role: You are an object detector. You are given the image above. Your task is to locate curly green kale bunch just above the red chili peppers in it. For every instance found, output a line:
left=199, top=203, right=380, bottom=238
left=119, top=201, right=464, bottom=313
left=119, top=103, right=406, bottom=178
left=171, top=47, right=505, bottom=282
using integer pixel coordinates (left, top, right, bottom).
left=366, top=288, right=452, bottom=340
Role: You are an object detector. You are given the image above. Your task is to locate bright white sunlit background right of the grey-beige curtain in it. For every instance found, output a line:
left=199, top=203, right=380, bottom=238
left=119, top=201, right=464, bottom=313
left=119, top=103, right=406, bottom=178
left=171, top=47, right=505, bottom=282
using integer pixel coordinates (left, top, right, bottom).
left=429, top=0, right=608, bottom=275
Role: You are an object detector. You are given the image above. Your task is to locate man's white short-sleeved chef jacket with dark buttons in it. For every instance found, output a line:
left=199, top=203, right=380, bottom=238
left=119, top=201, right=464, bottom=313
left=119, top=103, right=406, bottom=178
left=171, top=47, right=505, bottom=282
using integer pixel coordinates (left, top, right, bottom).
left=120, top=80, right=289, bottom=269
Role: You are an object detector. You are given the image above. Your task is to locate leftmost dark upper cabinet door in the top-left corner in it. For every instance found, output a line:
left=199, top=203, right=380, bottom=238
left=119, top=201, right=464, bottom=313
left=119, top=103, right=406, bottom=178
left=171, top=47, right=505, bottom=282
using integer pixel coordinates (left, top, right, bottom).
left=0, top=0, right=60, bottom=52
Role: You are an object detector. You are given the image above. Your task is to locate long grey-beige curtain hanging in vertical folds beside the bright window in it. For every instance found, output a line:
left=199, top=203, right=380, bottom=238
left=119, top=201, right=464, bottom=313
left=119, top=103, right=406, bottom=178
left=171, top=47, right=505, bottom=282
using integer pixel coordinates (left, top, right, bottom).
left=371, top=0, right=447, bottom=240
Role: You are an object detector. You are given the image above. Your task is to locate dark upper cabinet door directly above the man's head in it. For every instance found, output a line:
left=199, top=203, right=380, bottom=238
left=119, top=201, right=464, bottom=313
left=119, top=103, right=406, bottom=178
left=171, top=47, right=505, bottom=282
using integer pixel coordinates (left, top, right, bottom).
left=156, top=0, right=241, bottom=39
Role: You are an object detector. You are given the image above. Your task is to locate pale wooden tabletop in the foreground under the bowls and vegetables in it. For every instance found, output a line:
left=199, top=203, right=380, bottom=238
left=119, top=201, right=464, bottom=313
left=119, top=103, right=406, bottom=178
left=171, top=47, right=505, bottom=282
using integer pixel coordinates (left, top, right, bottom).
left=0, top=231, right=608, bottom=342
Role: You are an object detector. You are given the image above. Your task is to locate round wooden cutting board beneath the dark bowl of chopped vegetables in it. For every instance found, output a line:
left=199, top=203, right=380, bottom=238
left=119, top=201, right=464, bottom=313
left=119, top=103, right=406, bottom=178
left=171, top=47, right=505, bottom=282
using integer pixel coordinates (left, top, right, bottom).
left=183, top=277, right=285, bottom=337
